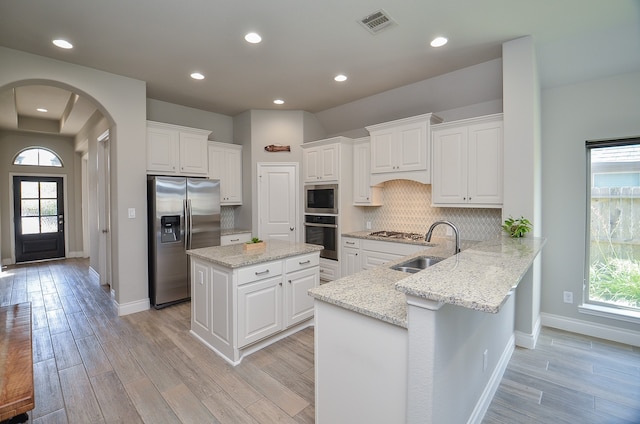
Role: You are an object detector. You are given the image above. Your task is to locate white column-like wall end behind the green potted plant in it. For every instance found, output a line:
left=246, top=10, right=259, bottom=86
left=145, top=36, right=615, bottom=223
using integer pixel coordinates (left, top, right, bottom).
left=502, top=37, right=542, bottom=348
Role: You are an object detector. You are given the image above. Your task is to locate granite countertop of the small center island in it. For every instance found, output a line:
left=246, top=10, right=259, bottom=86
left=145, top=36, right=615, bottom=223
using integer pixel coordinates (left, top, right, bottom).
left=187, top=240, right=323, bottom=268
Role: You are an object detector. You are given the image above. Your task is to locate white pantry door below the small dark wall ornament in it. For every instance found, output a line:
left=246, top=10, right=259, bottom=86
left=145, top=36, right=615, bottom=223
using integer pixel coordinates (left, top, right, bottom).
left=258, top=163, right=300, bottom=243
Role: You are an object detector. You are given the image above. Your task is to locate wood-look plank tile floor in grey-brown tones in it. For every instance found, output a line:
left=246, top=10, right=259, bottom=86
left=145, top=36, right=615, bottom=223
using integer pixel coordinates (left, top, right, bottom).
left=0, top=259, right=640, bottom=424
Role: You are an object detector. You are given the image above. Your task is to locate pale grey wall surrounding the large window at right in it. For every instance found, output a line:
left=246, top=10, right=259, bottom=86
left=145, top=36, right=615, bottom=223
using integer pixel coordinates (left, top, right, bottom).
left=542, top=69, right=640, bottom=337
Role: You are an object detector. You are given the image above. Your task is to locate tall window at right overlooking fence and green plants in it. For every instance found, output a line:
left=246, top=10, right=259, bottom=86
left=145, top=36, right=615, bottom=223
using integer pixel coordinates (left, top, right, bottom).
left=584, top=137, right=640, bottom=314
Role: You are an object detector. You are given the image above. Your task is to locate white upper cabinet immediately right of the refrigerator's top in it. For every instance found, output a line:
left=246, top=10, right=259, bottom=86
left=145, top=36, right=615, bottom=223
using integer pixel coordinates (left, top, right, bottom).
left=209, top=141, right=242, bottom=205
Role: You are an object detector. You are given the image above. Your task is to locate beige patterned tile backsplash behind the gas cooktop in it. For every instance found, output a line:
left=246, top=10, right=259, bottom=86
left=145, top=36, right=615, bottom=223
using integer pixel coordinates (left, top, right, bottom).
left=363, top=180, right=502, bottom=240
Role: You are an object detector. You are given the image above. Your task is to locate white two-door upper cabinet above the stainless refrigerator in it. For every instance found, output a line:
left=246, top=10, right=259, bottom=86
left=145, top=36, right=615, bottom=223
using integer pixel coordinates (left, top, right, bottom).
left=147, top=121, right=211, bottom=176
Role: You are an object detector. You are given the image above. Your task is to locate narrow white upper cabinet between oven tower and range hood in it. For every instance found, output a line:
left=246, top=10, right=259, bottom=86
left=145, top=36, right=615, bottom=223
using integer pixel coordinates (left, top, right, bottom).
left=353, top=137, right=382, bottom=206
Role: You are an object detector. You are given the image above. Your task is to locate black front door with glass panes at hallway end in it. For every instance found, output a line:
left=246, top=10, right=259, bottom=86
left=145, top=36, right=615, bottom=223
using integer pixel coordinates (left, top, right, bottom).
left=13, top=176, right=64, bottom=262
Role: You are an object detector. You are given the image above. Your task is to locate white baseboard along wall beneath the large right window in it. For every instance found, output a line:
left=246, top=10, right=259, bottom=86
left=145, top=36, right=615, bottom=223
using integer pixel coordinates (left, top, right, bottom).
left=540, top=312, right=640, bottom=347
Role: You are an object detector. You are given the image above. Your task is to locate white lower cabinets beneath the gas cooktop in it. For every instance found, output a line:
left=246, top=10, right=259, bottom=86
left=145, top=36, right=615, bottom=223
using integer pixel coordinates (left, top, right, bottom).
left=340, top=236, right=429, bottom=277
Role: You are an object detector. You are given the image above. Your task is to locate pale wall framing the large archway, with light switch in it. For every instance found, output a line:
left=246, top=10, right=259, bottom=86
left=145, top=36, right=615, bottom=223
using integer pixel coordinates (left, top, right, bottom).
left=0, top=47, right=149, bottom=313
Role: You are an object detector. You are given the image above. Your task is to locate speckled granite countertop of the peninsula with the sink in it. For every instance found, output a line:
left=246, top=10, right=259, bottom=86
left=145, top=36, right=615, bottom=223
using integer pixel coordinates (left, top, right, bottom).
left=309, top=234, right=545, bottom=328
